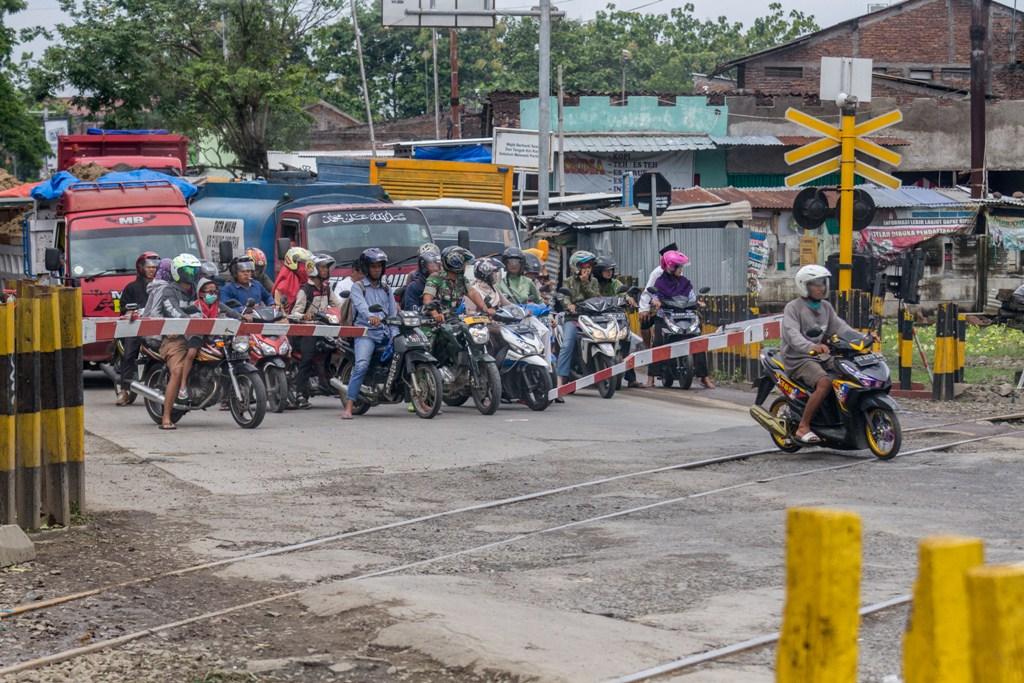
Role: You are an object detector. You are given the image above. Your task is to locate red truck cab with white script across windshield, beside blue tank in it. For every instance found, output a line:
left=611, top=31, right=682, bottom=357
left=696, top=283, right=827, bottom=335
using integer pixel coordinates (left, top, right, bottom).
left=276, top=204, right=432, bottom=291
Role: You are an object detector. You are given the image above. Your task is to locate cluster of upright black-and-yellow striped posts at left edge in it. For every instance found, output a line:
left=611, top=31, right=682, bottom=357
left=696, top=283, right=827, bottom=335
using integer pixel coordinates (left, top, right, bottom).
left=0, top=281, right=85, bottom=529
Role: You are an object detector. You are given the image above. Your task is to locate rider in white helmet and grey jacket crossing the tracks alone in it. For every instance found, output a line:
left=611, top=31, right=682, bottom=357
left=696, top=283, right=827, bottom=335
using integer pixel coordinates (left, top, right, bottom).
left=781, top=265, right=852, bottom=445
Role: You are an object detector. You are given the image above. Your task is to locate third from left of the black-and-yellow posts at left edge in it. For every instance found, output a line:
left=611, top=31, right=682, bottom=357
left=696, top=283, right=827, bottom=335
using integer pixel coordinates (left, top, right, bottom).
left=36, top=287, right=71, bottom=526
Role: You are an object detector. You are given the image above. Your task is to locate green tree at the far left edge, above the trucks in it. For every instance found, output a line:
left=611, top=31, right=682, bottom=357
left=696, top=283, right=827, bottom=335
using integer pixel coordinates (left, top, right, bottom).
left=0, top=0, right=49, bottom=175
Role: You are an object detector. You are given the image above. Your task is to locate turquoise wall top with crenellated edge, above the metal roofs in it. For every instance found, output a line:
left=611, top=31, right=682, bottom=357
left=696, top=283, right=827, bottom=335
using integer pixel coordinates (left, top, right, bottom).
left=519, top=95, right=729, bottom=135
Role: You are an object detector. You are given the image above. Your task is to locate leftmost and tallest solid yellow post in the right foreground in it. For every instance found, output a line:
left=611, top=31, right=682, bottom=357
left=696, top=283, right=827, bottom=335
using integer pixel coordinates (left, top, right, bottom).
left=775, top=508, right=860, bottom=683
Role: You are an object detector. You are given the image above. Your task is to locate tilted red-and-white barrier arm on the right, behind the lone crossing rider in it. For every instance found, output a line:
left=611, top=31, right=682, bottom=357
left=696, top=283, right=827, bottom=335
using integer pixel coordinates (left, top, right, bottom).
left=548, top=315, right=782, bottom=400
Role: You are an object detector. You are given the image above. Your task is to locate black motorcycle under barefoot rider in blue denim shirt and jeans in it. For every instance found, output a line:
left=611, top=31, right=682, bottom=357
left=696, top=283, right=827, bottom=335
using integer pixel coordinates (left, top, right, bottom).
left=331, top=304, right=444, bottom=420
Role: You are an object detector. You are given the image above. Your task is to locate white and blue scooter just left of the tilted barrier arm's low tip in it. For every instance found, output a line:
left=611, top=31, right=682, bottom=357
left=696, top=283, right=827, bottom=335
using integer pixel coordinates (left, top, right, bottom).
left=495, top=304, right=551, bottom=411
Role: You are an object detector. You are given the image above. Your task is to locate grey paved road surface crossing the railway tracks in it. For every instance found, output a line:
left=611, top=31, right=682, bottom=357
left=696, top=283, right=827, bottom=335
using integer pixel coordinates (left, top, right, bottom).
left=8, top=384, right=1024, bottom=682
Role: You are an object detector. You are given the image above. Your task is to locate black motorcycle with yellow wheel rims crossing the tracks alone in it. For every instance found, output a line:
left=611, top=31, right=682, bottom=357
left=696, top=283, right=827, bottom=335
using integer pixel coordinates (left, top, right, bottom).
left=751, top=329, right=903, bottom=460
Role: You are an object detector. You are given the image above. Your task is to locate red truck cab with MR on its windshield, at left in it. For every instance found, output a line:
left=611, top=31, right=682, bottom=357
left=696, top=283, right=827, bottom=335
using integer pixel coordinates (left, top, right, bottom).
left=50, top=181, right=203, bottom=362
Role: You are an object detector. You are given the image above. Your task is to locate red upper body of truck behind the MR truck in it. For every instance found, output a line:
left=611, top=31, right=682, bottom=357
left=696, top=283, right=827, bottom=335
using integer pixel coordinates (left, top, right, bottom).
left=57, top=133, right=188, bottom=176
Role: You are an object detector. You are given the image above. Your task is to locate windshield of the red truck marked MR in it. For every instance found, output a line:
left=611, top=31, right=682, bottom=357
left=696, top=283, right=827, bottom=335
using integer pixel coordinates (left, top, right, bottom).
left=69, top=223, right=200, bottom=278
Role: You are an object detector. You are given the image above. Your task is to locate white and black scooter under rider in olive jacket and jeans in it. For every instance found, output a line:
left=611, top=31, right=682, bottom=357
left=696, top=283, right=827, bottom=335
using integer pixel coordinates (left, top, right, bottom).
left=555, top=288, right=630, bottom=398
